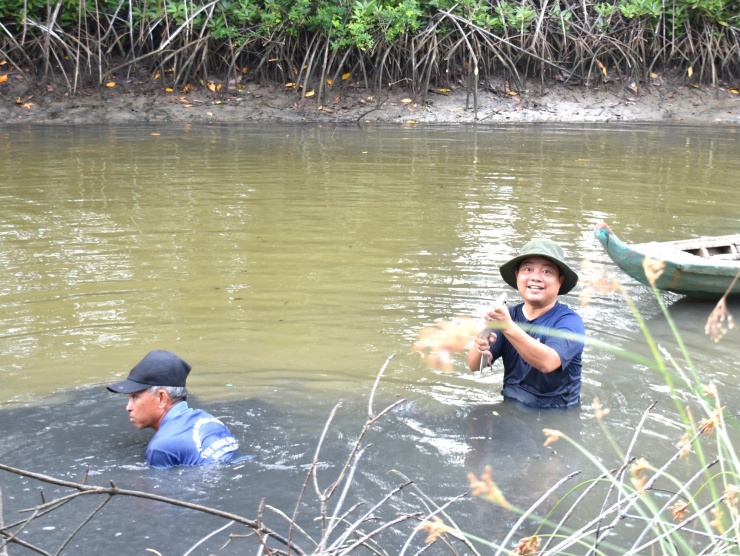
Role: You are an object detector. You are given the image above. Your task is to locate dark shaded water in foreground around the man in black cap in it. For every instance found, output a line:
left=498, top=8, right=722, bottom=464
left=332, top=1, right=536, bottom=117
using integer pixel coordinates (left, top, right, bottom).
left=0, top=378, right=580, bottom=556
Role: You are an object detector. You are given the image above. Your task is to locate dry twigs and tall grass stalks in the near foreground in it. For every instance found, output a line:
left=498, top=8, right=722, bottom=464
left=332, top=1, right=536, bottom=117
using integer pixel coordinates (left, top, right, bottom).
left=0, top=259, right=740, bottom=556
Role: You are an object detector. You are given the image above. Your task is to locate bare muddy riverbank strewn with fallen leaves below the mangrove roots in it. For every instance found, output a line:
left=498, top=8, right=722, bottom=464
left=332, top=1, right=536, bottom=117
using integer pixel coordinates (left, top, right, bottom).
left=0, top=68, right=740, bottom=125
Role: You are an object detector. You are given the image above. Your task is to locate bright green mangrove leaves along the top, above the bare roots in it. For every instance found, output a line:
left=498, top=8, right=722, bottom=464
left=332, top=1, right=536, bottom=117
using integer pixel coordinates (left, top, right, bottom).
left=0, top=0, right=740, bottom=43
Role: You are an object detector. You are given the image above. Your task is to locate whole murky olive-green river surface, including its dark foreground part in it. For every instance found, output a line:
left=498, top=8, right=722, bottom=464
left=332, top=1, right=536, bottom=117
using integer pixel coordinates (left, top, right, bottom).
left=0, top=125, right=740, bottom=556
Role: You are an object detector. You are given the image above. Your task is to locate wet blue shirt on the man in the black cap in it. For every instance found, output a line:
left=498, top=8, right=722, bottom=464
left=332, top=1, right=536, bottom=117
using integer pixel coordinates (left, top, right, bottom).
left=146, top=402, right=239, bottom=468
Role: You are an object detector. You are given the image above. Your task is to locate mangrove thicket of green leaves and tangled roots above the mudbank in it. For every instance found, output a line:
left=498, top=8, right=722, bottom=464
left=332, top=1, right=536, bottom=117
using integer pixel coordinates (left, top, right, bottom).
left=0, top=0, right=740, bottom=96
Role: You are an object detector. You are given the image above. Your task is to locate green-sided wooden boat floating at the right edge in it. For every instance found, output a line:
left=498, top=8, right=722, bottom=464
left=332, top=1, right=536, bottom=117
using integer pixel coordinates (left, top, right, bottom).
left=594, top=222, right=740, bottom=299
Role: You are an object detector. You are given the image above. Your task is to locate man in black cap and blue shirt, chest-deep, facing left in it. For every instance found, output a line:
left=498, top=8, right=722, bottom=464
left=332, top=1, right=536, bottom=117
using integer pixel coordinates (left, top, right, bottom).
left=108, top=350, right=239, bottom=468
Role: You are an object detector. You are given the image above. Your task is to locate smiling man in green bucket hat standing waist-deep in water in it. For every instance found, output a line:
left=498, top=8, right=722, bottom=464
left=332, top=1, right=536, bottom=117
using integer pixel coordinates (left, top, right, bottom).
left=468, top=239, right=585, bottom=408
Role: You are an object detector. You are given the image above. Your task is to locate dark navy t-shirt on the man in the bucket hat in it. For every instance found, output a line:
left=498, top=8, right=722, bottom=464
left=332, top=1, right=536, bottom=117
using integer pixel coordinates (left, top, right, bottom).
left=491, top=301, right=585, bottom=408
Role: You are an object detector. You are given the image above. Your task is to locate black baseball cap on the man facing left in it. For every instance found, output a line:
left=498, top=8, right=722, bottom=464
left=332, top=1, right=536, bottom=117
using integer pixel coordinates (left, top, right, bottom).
left=108, top=349, right=191, bottom=394
